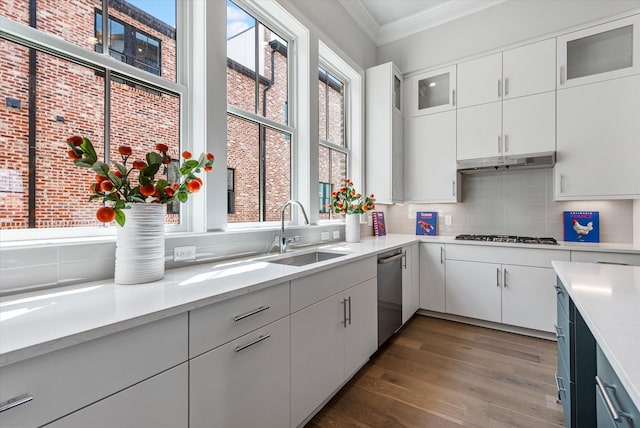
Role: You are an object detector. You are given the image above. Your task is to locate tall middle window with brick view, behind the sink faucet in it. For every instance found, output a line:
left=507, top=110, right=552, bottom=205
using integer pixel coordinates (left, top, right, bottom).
left=227, top=1, right=294, bottom=223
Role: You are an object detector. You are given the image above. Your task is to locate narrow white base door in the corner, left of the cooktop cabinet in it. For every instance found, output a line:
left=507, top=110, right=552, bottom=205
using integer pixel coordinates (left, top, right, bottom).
left=420, top=242, right=445, bottom=312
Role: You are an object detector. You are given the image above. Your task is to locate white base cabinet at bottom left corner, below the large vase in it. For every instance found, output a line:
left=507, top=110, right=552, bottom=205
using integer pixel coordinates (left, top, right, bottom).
left=0, top=314, right=189, bottom=428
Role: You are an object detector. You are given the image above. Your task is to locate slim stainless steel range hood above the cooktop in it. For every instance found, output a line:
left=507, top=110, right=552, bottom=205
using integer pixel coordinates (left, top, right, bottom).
left=457, top=152, right=556, bottom=174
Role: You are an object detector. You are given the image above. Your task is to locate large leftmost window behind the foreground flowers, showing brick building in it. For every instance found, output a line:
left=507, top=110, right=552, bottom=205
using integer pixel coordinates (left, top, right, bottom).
left=0, top=0, right=180, bottom=239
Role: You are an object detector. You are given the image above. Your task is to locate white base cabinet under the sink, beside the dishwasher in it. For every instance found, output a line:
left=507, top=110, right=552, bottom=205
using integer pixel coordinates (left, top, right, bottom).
left=288, top=257, right=378, bottom=427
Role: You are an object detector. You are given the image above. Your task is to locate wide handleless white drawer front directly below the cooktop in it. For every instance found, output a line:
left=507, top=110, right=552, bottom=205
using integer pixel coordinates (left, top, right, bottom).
left=447, top=244, right=570, bottom=268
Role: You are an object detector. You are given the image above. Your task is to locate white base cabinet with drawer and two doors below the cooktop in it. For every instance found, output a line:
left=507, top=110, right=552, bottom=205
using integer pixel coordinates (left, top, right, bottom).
left=445, top=244, right=569, bottom=332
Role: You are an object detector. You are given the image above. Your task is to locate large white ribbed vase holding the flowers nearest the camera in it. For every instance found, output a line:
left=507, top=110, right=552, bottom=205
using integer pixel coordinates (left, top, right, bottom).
left=114, top=203, right=165, bottom=284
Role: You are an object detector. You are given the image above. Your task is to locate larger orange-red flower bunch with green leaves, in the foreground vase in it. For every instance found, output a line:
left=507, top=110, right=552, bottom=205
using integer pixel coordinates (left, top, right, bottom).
left=67, top=135, right=214, bottom=226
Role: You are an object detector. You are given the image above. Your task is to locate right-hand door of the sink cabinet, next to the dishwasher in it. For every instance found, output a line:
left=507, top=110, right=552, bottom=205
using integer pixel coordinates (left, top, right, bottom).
left=344, top=279, right=378, bottom=377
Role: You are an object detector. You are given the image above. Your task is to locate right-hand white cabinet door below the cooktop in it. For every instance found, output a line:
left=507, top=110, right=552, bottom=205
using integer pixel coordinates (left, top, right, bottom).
left=502, top=265, right=557, bottom=332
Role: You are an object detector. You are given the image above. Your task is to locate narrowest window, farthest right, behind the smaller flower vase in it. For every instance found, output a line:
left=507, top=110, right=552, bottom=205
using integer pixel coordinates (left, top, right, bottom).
left=318, top=67, right=349, bottom=219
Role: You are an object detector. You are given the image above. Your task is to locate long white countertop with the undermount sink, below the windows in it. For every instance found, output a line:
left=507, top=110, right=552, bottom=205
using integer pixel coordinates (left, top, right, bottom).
left=0, top=235, right=417, bottom=366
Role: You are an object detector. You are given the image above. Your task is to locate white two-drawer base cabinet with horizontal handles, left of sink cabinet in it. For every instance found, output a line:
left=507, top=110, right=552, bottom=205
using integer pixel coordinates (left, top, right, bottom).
left=189, top=282, right=290, bottom=428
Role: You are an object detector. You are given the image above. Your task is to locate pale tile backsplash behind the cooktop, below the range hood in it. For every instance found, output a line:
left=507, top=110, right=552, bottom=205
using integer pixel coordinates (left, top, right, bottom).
left=386, top=169, right=633, bottom=243
